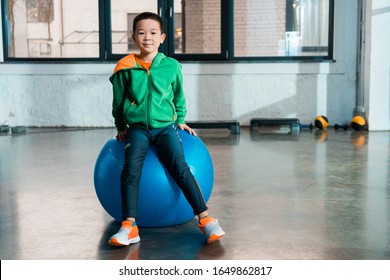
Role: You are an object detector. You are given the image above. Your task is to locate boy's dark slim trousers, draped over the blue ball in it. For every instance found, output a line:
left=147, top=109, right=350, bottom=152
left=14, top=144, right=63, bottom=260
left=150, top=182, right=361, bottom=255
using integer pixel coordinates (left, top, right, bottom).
left=121, top=124, right=207, bottom=219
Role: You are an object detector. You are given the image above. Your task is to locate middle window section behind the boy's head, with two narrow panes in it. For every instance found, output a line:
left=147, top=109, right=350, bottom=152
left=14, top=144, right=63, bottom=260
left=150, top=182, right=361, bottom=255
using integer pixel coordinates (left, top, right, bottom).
left=107, top=0, right=228, bottom=60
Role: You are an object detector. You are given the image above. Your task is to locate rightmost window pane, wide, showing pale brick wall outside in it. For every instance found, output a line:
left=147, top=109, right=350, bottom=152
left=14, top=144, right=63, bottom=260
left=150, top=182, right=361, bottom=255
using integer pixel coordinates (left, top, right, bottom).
left=234, top=0, right=329, bottom=57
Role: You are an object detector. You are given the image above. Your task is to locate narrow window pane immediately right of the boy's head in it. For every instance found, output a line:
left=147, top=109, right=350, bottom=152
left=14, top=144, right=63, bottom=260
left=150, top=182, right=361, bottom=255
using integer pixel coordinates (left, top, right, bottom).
left=174, top=0, right=221, bottom=54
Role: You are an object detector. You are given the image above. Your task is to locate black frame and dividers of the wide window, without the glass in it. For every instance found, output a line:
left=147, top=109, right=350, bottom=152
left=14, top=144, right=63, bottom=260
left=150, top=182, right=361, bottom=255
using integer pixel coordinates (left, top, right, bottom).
left=1, top=0, right=334, bottom=63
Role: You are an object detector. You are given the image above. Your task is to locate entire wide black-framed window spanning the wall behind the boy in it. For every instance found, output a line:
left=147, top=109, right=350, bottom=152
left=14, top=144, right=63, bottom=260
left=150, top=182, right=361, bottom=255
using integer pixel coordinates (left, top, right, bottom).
left=1, top=0, right=334, bottom=61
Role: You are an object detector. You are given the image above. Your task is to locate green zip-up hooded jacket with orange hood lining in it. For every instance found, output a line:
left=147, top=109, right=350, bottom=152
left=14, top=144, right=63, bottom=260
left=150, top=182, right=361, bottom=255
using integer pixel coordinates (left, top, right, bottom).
left=110, top=53, right=187, bottom=132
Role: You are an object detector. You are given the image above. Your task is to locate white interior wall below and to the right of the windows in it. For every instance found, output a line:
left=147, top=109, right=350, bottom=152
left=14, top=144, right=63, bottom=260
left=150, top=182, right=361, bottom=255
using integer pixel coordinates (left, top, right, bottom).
left=0, top=0, right=380, bottom=130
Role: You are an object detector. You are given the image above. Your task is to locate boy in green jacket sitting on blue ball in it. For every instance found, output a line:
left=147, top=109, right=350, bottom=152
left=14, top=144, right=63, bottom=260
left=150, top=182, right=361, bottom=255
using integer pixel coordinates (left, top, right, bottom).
left=108, top=12, right=225, bottom=246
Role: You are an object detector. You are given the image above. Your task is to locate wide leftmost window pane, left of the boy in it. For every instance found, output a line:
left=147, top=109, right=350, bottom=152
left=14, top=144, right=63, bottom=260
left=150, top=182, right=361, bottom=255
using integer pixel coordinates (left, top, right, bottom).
left=6, top=0, right=99, bottom=58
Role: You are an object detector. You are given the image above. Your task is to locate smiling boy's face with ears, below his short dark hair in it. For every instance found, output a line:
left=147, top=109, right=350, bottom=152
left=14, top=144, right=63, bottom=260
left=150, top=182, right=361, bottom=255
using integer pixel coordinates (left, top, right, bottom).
left=133, top=19, right=165, bottom=55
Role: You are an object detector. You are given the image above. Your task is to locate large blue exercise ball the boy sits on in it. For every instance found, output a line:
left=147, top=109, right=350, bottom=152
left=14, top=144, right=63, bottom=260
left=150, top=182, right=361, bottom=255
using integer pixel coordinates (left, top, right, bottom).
left=94, top=130, right=214, bottom=227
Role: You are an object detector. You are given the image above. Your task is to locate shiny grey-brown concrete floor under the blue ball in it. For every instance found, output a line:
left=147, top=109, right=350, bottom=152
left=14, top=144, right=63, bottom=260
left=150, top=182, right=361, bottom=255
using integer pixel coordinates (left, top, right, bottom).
left=0, top=127, right=390, bottom=260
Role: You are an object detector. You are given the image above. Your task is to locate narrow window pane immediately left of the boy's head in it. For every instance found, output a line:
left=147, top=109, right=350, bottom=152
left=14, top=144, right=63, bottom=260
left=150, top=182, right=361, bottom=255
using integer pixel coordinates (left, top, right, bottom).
left=111, top=0, right=157, bottom=54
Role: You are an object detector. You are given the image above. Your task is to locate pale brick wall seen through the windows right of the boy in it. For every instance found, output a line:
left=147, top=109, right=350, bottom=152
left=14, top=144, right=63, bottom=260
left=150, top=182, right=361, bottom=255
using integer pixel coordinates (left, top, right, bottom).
left=183, top=0, right=286, bottom=56
